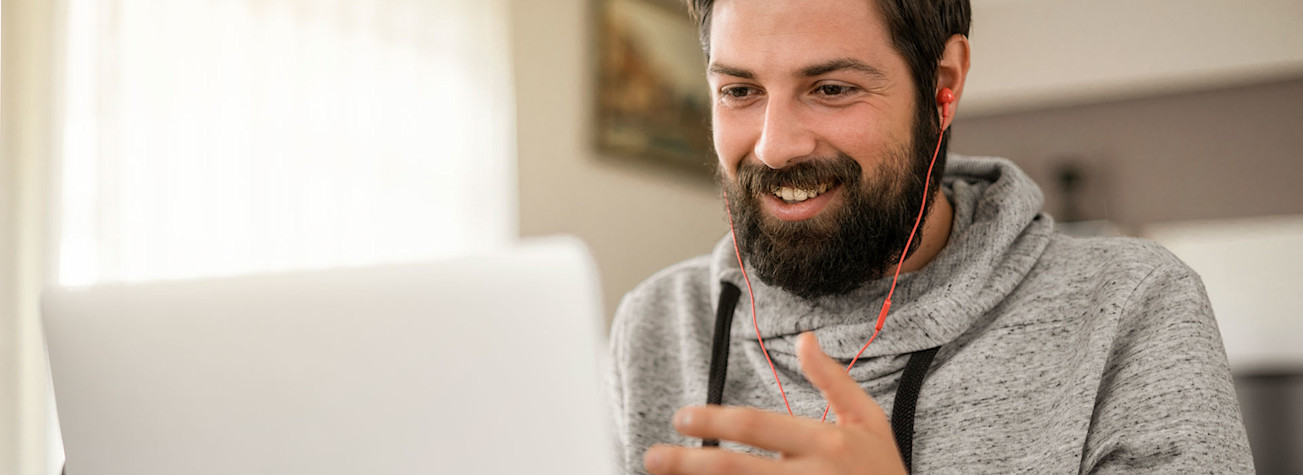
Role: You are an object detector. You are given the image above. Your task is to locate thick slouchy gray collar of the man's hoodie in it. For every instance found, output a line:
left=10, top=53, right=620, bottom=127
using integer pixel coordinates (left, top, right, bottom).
left=710, top=154, right=1053, bottom=359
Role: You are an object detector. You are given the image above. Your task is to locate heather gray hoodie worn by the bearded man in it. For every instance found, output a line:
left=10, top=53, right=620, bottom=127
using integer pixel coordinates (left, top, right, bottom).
left=611, top=155, right=1253, bottom=474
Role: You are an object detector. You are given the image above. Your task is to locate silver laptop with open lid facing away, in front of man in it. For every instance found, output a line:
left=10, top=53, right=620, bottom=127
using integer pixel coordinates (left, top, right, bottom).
left=43, top=238, right=614, bottom=475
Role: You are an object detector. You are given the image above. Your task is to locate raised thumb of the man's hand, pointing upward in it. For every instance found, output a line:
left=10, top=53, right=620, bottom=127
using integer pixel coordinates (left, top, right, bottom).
left=796, top=332, right=891, bottom=435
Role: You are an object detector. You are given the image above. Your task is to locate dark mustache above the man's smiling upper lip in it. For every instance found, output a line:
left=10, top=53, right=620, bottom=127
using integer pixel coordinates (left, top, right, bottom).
left=737, top=154, right=864, bottom=195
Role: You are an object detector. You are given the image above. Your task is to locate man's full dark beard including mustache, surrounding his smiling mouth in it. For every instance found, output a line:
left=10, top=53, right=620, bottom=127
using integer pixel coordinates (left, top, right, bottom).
left=721, top=110, right=943, bottom=299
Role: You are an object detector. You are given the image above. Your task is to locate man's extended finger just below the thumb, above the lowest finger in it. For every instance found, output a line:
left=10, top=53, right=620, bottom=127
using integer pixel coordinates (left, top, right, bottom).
left=674, top=406, right=837, bottom=455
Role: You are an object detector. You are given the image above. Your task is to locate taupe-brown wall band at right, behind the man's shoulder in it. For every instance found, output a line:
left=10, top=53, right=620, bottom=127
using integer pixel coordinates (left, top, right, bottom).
left=951, top=79, right=1303, bottom=229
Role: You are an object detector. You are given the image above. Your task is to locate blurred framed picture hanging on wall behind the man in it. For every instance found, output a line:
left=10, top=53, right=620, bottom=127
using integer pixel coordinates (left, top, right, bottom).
left=595, top=0, right=715, bottom=177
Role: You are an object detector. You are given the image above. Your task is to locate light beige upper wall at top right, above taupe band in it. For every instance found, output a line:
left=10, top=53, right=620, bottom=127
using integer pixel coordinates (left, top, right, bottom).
left=964, top=0, right=1303, bottom=113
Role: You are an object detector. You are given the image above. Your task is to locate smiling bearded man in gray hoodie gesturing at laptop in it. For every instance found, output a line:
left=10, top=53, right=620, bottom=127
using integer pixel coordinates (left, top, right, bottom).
left=611, top=0, right=1253, bottom=474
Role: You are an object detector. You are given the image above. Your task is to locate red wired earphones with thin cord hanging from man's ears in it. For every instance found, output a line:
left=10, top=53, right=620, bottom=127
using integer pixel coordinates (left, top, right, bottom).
left=724, top=87, right=955, bottom=420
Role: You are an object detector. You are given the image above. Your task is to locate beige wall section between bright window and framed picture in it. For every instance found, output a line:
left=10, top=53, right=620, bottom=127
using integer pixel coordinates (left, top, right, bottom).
left=512, top=0, right=728, bottom=320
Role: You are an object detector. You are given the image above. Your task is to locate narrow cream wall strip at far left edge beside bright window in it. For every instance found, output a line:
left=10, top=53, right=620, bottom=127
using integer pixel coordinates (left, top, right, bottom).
left=0, top=0, right=60, bottom=475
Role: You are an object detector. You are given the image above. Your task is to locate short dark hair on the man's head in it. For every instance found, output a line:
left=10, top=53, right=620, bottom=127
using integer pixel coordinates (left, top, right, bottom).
left=684, top=0, right=972, bottom=167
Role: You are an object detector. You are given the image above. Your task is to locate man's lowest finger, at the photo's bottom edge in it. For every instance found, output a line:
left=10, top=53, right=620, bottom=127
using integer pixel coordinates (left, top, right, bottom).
left=642, top=445, right=786, bottom=475
